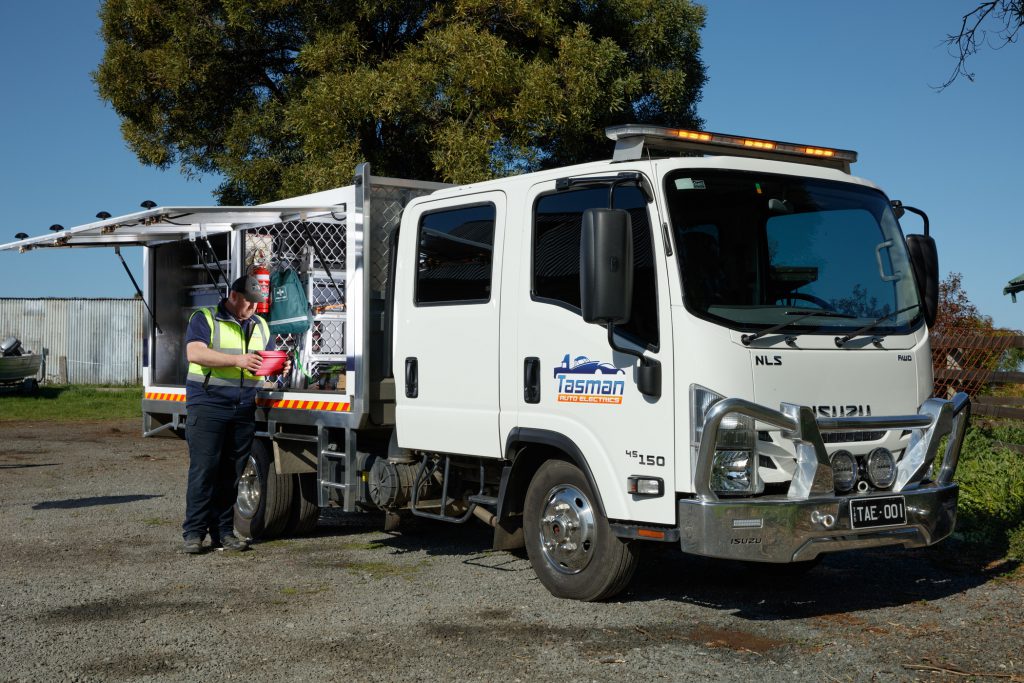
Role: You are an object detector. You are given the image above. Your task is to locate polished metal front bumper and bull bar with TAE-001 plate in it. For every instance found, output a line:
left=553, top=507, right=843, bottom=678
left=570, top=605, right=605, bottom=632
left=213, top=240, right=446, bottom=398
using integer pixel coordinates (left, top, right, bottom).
left=679, top=394, right=971, bottom=562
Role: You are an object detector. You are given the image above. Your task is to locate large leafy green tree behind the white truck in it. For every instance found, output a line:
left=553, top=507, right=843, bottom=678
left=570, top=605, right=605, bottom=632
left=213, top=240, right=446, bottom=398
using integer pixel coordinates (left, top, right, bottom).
left=93, top=0, right=706, bottom=204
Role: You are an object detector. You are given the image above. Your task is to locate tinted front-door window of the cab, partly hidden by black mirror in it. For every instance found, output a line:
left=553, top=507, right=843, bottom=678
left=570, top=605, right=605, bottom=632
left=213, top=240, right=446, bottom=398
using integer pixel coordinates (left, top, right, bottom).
left=532, top=186, right=658, bottom=348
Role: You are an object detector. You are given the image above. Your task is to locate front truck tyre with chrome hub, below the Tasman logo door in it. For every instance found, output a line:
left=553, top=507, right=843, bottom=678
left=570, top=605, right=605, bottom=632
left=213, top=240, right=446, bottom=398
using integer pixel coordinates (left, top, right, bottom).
left=523, top=460, right=638, bottom=601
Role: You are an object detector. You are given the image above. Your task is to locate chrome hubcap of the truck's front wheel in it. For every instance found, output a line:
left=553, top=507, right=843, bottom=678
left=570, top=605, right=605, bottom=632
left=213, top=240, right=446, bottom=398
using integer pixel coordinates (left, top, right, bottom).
left=541, top=484, right=594, bottom=573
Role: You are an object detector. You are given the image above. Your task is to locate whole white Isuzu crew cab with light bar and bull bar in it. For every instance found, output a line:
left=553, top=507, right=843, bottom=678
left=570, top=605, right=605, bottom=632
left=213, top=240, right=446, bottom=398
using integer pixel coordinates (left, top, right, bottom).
left=394, top=127, right=969, bottom=599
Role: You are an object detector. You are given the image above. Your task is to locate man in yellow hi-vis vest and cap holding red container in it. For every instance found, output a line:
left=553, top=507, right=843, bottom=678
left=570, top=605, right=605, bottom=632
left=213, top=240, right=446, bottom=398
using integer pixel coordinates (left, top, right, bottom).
left=181, top=276, right=291, bottom=554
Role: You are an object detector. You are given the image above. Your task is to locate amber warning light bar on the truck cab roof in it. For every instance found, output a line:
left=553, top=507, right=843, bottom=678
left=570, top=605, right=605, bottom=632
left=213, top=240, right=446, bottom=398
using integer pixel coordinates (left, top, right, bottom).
left=604, top=124, right=857, bottom=169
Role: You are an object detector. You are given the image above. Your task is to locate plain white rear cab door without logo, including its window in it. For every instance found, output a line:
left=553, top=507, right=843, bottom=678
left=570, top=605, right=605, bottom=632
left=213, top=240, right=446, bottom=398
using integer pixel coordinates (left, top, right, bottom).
left=394, top=191, right=506, bottom=458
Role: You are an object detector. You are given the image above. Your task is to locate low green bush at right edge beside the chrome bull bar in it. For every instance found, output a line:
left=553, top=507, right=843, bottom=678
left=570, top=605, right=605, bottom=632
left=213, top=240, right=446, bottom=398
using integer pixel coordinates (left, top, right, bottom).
left=956, top=423, right=1024, bottom=556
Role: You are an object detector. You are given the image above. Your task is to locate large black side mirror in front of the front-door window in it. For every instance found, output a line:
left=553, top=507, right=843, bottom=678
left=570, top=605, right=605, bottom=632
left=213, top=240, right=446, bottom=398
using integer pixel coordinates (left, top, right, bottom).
left=580, top=209, right=633, bottom=325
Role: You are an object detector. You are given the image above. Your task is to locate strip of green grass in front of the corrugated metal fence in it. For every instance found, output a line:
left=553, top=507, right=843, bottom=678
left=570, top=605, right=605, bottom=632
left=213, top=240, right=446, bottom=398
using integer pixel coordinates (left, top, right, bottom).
left=0, top=386, right=142, bottom=422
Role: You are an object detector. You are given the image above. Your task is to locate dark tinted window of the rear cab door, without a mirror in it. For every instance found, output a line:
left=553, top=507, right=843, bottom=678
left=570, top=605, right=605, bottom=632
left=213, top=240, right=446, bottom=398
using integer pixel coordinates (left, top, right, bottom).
left=414, top=204, right=496, bottom=304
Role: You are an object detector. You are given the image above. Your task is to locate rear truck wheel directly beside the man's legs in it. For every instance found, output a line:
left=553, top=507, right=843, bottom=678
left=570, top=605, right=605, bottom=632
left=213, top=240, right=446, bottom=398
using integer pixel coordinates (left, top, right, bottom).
left=234, top=438, right=295, bottom=541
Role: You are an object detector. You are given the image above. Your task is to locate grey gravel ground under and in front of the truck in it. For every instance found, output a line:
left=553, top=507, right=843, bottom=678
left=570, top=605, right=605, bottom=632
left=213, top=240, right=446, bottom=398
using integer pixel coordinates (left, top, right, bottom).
left=0, top=421, right=1024, bottom=682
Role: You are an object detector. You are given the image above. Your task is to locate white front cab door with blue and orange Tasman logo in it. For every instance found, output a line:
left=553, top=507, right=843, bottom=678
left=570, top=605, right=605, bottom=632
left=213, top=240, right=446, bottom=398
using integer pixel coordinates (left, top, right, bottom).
left=514, top=181, right=676, bottom=524
